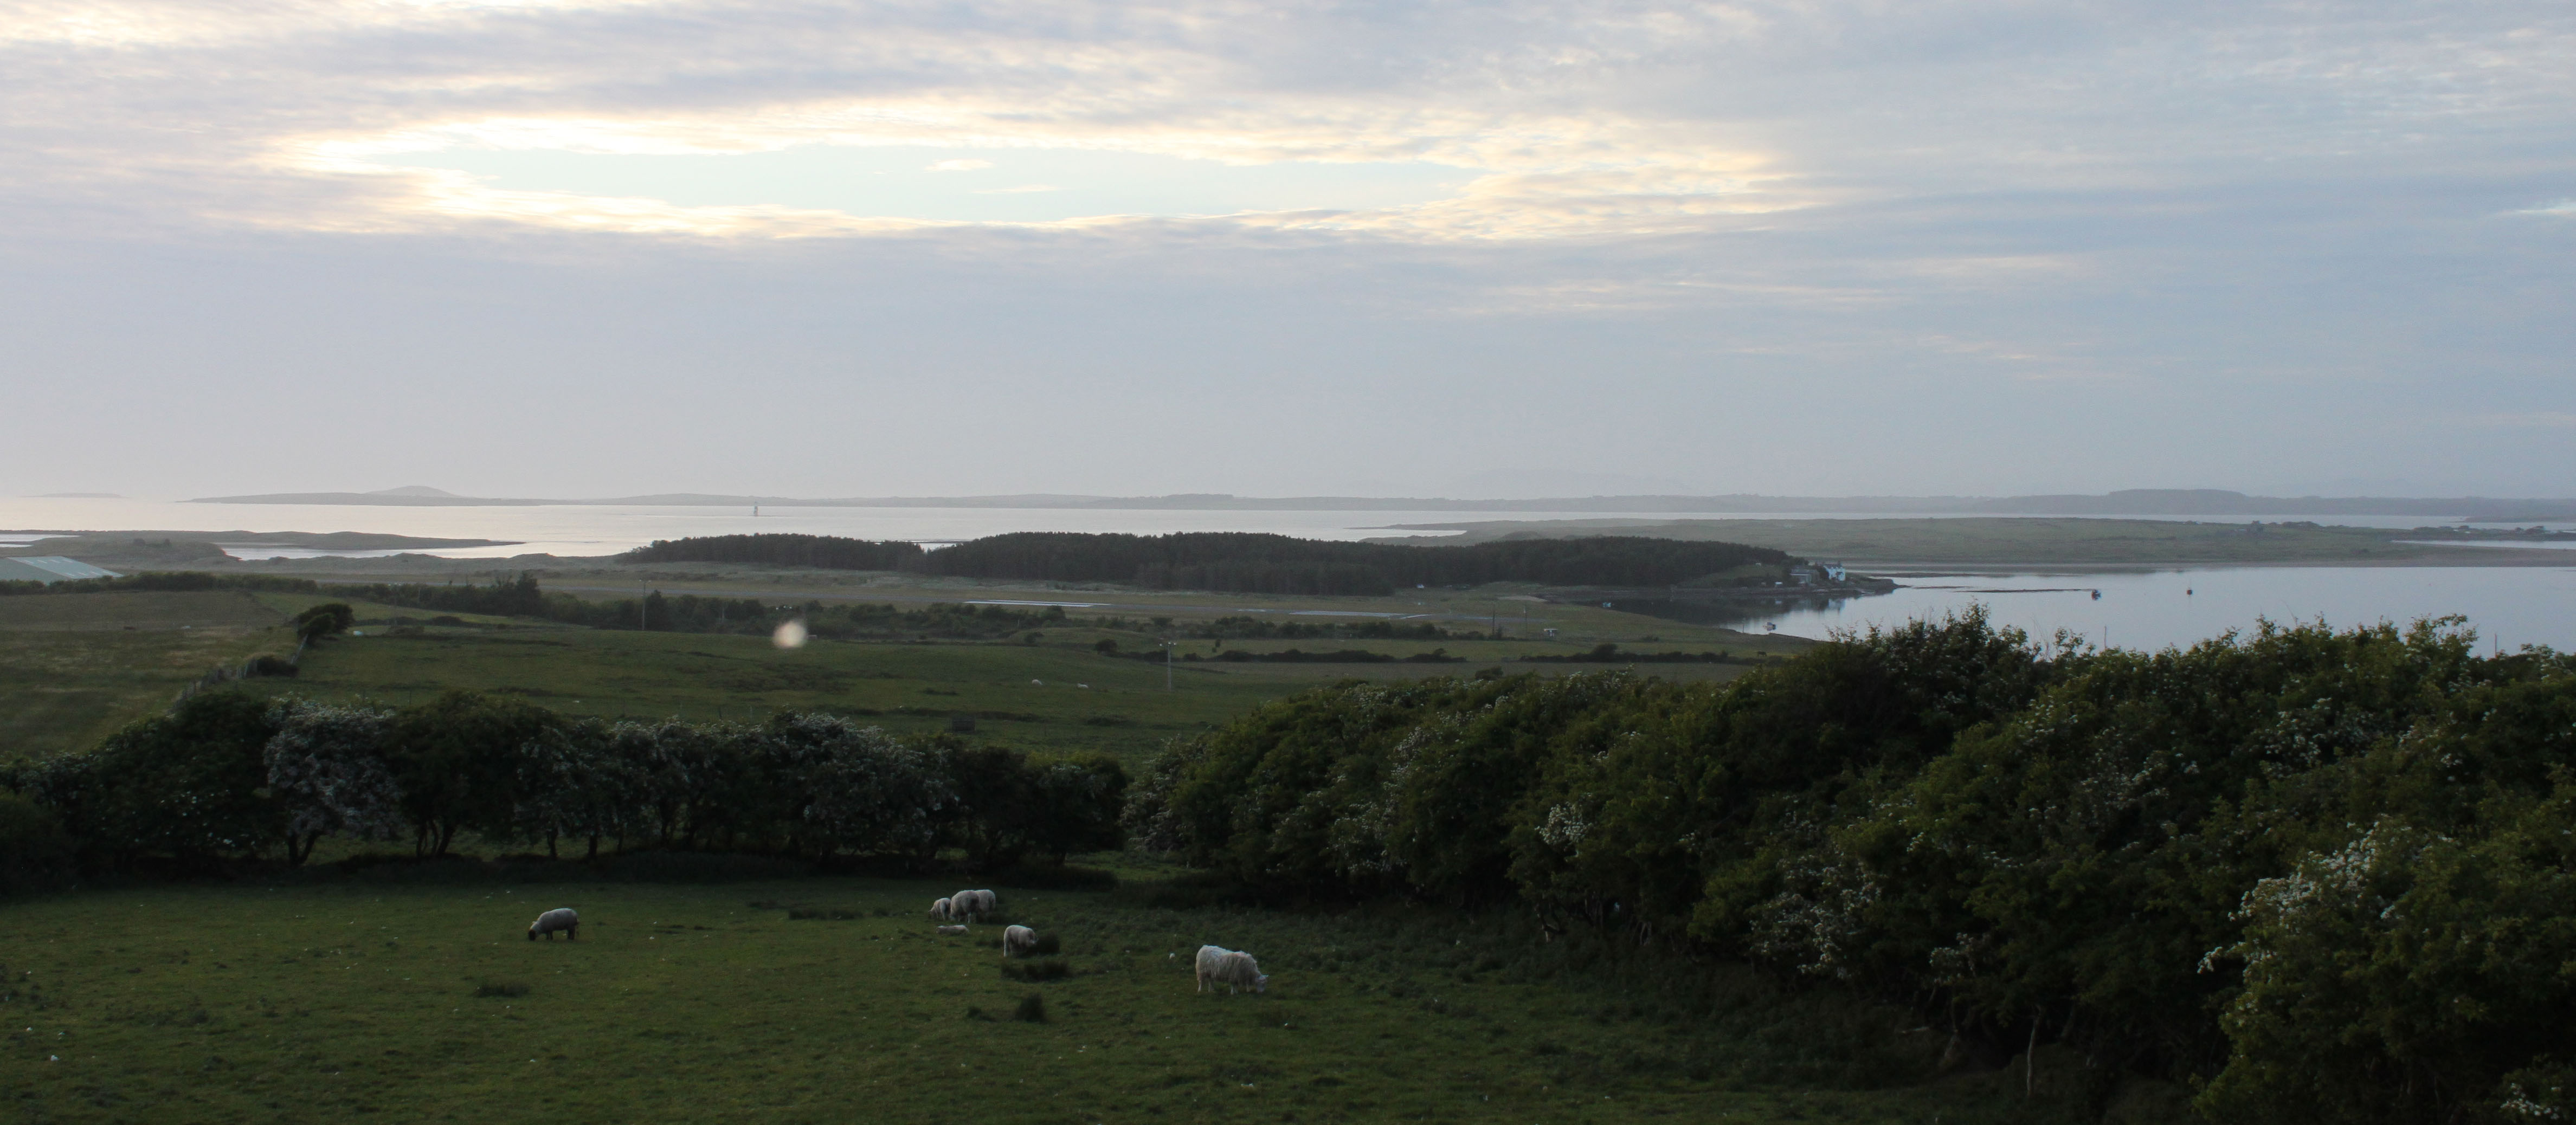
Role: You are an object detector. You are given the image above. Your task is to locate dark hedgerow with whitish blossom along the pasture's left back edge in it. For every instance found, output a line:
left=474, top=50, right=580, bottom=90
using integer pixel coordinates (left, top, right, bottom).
left=0, top=690, right=1126, bottom=881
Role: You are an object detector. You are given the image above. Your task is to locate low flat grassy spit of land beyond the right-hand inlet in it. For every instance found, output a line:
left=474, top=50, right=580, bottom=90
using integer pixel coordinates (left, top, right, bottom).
left=1370, top=518, right=2566, bottom=566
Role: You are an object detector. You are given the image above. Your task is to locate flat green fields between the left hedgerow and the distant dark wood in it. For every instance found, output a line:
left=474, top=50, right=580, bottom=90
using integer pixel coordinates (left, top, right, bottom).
left=0, top=574, right=1806, bottom=759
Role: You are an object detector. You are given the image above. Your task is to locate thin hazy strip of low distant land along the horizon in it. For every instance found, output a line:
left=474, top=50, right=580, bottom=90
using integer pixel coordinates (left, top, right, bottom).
left=191, top=484, right=2576, bottom=522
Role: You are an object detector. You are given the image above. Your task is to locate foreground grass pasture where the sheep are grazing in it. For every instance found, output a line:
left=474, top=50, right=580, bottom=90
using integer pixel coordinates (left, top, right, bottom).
left=0, top=868, right=2112, bottom=1122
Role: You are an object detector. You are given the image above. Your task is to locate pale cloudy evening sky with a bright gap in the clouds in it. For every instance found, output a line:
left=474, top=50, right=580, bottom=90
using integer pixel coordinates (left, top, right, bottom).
left=0, top=0, right=2576, bottom=497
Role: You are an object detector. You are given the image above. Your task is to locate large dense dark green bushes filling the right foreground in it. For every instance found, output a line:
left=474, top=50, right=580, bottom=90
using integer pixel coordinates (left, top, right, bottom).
left=1128, top=615, right=2576, bottom=1122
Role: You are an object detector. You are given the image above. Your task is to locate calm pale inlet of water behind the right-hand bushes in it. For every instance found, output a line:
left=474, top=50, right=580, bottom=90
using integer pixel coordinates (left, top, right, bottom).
left=1618, top=566, right=2576, bottom=651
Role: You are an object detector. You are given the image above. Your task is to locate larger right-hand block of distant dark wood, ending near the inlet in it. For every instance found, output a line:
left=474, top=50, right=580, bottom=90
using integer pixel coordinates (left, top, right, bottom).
left=922, top=531, right=1788, bottom=594
